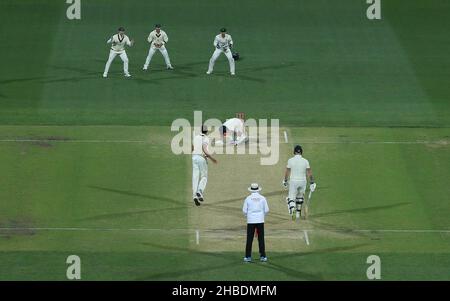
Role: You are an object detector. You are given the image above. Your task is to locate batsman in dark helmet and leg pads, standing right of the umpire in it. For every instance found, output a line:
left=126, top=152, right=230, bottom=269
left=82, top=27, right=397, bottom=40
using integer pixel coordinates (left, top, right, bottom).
left=283, top=145, right=316, bottom=219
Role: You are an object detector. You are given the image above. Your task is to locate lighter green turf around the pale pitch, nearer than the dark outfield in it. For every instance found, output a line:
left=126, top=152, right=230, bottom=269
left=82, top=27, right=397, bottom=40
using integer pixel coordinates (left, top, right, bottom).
left=0, top=126, right=450, bottom=280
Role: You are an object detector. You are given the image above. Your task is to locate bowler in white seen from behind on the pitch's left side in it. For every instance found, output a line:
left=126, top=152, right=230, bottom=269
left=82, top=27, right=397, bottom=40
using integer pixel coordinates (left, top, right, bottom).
left=192, top=126, right=217, bottom=206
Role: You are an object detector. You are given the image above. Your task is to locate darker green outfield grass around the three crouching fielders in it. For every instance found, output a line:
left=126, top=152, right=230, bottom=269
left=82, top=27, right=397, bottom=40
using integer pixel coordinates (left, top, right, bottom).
left=0, top=0, right=450, bottom=127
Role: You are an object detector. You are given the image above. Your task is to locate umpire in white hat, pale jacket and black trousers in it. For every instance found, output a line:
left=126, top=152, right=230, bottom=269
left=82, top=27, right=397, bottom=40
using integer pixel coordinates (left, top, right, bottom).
left=242, top=183, right=269, bottom=262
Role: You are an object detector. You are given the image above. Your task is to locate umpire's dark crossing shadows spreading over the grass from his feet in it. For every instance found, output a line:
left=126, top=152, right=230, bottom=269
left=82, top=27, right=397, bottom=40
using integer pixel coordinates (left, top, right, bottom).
left=135, top=242, right=322, bottom=280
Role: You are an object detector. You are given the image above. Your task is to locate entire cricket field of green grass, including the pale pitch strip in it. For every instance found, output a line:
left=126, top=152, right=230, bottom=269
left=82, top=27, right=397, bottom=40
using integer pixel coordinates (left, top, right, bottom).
left=0, top=0, right=450, bottom=280
